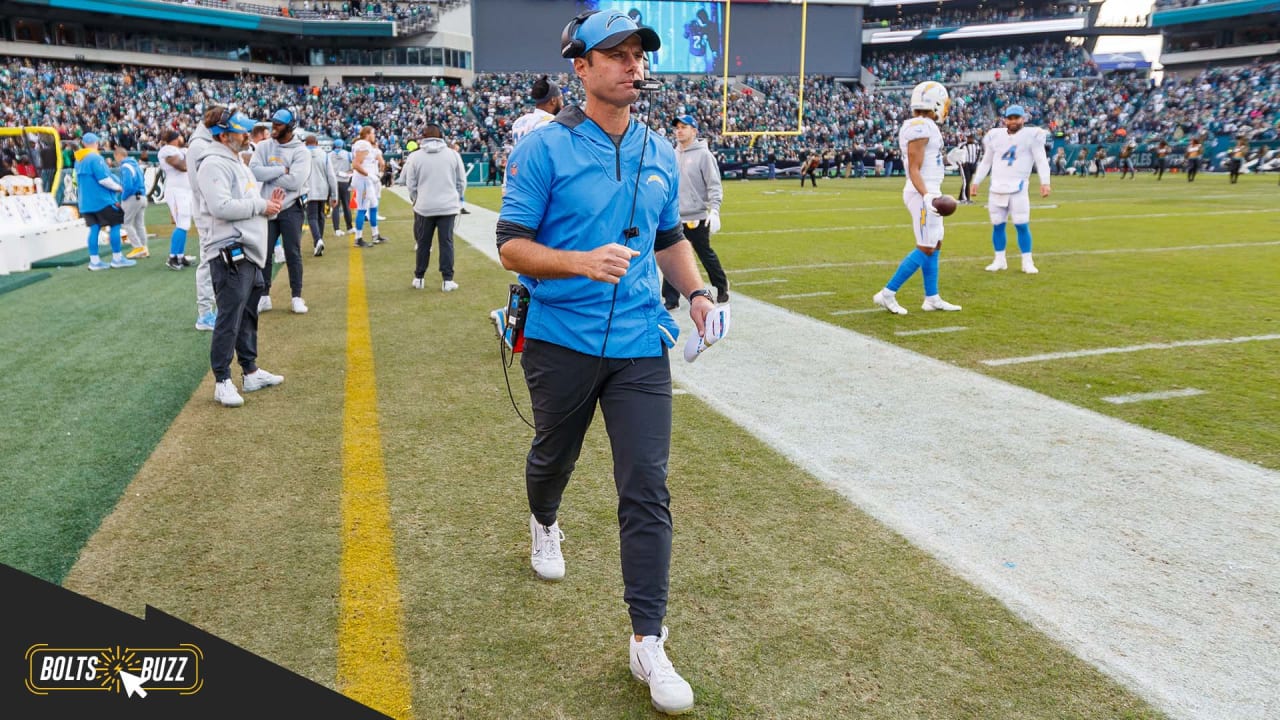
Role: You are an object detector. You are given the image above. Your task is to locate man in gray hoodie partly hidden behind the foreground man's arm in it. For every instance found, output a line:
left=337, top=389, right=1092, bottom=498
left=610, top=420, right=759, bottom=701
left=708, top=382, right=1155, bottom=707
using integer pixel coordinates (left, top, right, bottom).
left=662, top=115, right=728, bottom=310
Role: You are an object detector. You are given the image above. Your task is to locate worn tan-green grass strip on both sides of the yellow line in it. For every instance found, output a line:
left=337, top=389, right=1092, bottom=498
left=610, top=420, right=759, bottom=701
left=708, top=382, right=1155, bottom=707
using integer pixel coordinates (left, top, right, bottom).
left=42, top=186, right=1158, bottom=719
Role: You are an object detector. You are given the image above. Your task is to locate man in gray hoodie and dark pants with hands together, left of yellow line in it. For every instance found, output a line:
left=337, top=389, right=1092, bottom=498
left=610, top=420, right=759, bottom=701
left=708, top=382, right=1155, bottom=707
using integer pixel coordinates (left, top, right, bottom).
left=196, top=113, right=284, bottom=407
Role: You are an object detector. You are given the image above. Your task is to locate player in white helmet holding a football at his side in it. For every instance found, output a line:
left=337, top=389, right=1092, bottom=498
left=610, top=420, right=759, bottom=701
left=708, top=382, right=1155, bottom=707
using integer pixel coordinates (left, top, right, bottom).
left=872, top=81, right=960, bottom=315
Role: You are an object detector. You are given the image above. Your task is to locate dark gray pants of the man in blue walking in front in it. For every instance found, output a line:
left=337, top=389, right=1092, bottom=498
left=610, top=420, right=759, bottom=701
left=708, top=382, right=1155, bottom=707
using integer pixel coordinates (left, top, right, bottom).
left=520, top=340, right=671, bottom=635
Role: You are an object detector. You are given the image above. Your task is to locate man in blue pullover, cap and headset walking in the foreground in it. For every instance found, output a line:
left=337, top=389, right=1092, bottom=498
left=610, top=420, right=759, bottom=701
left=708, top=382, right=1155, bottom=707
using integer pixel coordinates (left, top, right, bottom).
left=498, top=12, right=714, bottom=712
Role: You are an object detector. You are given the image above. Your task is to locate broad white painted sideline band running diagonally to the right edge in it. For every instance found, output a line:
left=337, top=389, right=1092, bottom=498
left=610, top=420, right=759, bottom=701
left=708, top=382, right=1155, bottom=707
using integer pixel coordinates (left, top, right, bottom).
left=457, top=198, right=1280, bottom=720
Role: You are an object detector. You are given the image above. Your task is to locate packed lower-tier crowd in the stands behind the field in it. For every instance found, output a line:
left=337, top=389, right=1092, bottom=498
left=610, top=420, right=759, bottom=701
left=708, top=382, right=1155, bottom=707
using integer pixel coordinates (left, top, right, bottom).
left=0, top=52, right=1280, bottom=178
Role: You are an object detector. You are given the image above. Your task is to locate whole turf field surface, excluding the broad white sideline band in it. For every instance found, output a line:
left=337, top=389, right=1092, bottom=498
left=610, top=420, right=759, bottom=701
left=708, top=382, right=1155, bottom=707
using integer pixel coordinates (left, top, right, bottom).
left=0, top=170, right=1280, bottom=719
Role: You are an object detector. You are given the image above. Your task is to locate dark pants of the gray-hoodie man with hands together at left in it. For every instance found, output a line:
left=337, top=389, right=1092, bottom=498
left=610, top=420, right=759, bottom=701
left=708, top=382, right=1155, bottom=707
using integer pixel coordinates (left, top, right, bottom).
left=209, top=251, right=263, bottom=382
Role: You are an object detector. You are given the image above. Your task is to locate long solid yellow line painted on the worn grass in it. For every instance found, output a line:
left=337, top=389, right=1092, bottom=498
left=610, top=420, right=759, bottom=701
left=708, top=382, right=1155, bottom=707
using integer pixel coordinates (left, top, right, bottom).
left=338, top=243, right=412, bottom=717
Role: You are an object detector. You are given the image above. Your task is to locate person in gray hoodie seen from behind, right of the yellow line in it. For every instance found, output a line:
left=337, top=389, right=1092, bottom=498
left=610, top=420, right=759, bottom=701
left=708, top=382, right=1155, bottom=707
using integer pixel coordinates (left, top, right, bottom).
left=401, top=124, right=467, bottom=292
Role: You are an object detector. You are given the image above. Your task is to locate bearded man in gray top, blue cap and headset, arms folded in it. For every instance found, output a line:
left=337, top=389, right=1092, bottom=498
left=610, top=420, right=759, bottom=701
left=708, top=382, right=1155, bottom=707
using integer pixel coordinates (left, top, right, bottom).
left=248, top=109, right=311, bottom=313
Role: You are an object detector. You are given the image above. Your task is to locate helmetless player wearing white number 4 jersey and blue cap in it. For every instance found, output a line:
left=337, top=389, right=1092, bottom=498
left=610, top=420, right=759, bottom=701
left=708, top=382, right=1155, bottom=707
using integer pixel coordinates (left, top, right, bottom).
left=969, top=105, right=1050, bottom=274
